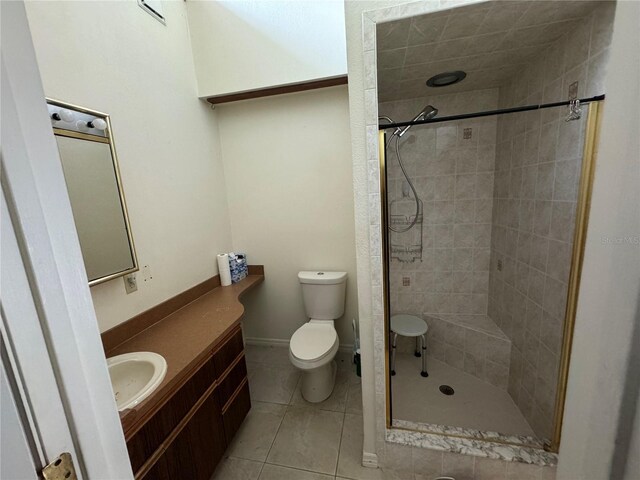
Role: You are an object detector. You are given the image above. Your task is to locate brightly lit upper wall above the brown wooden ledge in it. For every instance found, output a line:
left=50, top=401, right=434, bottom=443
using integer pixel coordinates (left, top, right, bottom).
left=186, top=0, right=347, bottom=97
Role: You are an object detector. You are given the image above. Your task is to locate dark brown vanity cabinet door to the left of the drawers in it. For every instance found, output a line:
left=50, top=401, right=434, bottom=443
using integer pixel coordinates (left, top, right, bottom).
left=154, top=391, right=227, bottom=480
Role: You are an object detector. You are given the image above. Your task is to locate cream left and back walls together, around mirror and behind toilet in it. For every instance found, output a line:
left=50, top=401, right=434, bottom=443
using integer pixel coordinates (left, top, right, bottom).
left=27, top=2, right=357, bottom=344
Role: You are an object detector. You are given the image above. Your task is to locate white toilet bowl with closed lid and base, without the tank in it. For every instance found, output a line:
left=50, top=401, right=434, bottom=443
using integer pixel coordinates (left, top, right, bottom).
left=289, top=320, right=339, bottom=403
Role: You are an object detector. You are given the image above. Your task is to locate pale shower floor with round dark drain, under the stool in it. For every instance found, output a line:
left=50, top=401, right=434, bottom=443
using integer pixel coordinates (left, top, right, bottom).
left=391, top=353, right=534, bottom=436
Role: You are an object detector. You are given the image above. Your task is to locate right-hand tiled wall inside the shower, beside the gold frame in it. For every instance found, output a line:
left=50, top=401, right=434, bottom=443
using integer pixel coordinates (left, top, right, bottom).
left=485, top=2, right=615, bottom=438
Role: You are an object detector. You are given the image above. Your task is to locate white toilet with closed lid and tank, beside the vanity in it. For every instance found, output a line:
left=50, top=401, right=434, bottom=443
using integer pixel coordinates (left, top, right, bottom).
left=289, top=271, right=347, bottom=403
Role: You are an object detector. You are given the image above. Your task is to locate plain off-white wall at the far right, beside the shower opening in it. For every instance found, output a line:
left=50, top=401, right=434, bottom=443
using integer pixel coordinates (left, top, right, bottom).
left=558, top=1, right=640, bottom=480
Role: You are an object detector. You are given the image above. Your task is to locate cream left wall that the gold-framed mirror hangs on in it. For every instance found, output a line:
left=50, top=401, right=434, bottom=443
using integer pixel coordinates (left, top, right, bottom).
left=27, top=1, right=231, bottom=331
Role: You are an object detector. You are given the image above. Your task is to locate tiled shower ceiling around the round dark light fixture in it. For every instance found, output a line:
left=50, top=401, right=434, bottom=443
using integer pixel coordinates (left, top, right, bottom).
left=376, top=0, right=601, bottom=102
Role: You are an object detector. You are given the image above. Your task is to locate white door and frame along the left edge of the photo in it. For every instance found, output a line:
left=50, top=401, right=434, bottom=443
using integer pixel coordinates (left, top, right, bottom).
left=0, top=1, right=133, bottom=480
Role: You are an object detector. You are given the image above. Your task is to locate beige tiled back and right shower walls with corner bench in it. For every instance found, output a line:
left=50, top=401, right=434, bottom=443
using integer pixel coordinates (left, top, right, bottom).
left=379, top=0, right=614, bottom=438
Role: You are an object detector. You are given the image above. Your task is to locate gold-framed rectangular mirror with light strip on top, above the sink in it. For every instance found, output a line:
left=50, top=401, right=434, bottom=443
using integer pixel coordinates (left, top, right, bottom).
left=47, top=100, right=138, bottom=286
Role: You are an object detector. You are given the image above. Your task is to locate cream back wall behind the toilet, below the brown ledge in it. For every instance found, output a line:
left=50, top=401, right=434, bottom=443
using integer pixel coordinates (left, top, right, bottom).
left=216, top=86, right=357, bottom=344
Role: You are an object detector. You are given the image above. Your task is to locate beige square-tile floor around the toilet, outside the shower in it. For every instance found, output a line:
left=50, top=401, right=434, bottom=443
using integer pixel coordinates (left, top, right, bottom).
left=212, top=345, right=370, bottom=480
